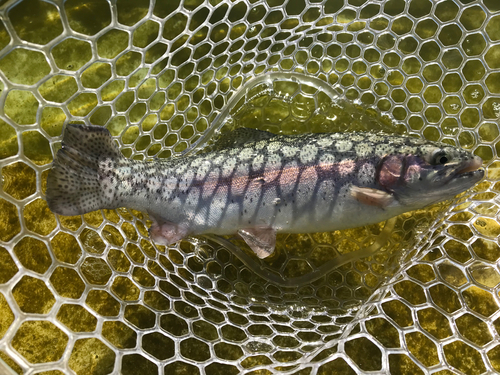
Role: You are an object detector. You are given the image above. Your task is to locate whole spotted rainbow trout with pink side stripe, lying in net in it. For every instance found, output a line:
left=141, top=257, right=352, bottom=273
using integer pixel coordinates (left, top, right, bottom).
left=46, top=124, right=484, bottom=258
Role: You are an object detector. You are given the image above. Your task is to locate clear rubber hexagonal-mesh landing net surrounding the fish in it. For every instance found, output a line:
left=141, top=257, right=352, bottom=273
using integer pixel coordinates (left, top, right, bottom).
left=0, top=0, right=500, bottom=374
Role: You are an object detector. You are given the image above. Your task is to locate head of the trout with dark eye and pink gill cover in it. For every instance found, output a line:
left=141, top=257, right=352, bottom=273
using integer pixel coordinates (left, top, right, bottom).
left=378, top=144, right=484, bottom=209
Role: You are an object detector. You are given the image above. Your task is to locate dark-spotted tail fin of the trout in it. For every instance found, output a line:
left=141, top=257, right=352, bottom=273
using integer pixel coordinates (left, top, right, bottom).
left=46, top=124, right=123, bottom=216
